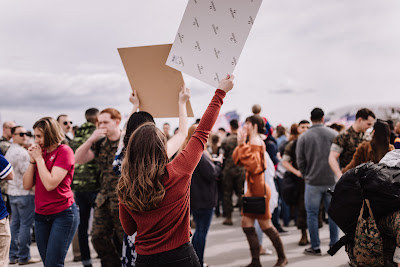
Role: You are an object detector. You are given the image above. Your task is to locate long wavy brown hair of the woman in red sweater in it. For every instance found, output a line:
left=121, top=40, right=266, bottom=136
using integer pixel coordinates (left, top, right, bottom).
left=116, top=122, right=168, bottom=212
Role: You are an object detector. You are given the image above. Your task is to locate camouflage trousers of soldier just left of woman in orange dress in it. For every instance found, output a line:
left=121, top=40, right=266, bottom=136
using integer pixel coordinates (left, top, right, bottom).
left=223, top=168, right=246, bottom=217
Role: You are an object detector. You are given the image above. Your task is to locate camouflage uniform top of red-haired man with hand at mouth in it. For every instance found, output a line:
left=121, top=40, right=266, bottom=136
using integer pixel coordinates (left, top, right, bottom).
left=91, top=138, right=119, bottom=207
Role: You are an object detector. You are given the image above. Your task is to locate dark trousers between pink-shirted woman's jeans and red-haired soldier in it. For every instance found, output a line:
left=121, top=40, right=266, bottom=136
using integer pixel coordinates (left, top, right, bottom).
left=75, top=191, right=98, bottom=265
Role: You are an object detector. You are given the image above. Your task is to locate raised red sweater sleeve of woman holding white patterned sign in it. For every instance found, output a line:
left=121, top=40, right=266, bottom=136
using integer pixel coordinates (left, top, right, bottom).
left=171, top=89, right=226, bottom=177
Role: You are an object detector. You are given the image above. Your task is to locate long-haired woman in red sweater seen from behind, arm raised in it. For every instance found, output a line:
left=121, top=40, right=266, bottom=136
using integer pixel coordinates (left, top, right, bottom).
left=117, top=75, right=233, bottom=267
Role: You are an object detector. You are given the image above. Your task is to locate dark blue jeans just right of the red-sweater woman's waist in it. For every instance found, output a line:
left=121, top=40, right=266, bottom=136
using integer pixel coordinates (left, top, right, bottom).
left=192, top=209, right=214, bottom=266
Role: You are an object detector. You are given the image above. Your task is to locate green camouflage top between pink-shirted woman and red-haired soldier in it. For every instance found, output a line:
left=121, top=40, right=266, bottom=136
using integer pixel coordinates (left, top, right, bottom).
left=69, top=122, right=100, bottom=192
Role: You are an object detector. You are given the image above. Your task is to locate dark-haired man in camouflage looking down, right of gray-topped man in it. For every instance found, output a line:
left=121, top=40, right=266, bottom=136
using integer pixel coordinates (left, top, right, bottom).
left=329, top=108, right=375, bottom=179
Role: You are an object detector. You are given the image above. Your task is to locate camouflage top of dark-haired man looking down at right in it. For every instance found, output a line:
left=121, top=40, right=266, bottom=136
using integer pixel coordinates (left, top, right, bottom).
left=331, top=126, right=364, bottom=168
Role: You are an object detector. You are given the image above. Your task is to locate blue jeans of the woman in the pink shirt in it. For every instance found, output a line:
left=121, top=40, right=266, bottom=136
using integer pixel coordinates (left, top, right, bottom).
left=35, top=203, right=79, bottom=267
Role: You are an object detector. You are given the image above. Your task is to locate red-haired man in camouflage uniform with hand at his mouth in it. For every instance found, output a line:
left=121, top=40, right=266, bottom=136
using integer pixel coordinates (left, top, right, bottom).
left=75, top=108, right=124, bottom=267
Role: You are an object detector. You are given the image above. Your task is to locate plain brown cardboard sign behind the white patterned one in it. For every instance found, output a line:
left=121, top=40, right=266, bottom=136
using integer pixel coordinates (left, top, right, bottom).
left=118, top=44, right=193, bottom=118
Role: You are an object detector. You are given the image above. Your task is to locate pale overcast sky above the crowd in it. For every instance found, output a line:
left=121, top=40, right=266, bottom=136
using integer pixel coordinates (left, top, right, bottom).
left=0, top=0, right=400, bottom=132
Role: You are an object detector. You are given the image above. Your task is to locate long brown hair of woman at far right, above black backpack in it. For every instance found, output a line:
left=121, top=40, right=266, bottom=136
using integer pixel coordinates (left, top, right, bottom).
left=371, top=119, right=390, bottom=163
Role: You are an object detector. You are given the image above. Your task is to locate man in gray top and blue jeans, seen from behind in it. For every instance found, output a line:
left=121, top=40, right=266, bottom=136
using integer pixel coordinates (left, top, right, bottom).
left=296, top=108, right=339, bottom=256
